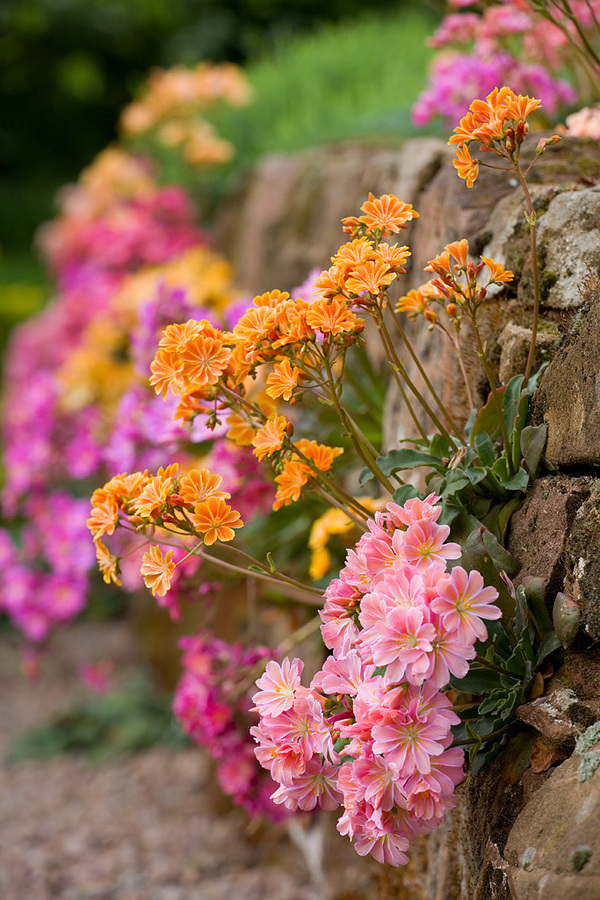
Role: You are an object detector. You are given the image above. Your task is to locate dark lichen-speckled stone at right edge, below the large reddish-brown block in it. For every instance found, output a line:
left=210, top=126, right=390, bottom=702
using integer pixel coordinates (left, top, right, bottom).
left=565, top=480, right=600, bottom=641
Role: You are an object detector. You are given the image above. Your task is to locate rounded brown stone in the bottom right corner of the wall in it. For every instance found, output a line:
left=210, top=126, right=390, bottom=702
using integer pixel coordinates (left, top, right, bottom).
left=503, top=755, right=600, bottom=900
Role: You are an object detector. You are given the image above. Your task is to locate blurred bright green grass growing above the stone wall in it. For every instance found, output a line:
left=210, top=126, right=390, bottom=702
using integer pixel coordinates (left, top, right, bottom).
left=209, top=6, right=437, bottom=185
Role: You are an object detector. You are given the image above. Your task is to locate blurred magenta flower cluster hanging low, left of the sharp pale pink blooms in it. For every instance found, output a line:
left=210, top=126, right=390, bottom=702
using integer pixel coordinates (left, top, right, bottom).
left=173, top=632, right=287, bottom=821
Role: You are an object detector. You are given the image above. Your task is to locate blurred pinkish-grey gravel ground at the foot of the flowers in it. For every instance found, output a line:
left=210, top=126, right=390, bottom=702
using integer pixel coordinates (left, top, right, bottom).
left=0, top=623, right=376, bottom=900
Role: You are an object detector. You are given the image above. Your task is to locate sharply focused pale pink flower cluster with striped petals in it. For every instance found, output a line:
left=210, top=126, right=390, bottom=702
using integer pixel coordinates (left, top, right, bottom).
left=252, top=494, right=501, bottom=865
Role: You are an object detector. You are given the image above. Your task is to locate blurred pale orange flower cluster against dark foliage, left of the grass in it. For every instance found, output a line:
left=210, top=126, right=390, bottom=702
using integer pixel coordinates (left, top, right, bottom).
left=121, top=62, right=251, bottom=166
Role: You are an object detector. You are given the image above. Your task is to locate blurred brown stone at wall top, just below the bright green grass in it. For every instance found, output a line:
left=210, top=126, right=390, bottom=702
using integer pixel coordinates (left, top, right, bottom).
left=214, top=138, right=449, bottom=293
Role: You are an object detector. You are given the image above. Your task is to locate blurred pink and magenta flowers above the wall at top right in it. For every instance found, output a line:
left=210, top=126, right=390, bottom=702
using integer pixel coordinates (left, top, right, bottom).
left=412, top=0, right=588, bottom=125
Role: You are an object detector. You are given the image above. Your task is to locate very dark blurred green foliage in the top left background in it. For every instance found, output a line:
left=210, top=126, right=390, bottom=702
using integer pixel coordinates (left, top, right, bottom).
left=0, top=0, right=418, bottom=252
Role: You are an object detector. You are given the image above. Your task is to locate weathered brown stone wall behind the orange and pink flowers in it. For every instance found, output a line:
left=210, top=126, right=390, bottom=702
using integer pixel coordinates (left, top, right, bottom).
left=216, top=139, right=600, bottom=900
